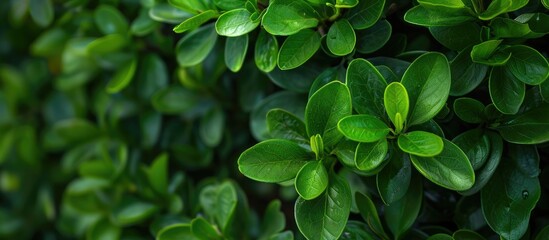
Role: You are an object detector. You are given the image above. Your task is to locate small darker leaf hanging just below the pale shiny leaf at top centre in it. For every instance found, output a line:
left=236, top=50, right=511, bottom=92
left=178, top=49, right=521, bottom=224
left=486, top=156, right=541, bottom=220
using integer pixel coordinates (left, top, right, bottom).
left=225, top=34, right=249, bottom=72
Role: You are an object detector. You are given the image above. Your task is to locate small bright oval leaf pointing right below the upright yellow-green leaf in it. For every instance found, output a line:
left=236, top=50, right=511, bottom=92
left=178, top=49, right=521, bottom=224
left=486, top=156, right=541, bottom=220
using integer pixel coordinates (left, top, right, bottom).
left=398, top=131, right=444, bottom=157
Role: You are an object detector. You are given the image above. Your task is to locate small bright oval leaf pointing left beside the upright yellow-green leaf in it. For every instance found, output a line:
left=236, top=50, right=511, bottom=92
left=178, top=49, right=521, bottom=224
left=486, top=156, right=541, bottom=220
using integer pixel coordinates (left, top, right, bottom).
left=337, top=114, right=390, bottom=142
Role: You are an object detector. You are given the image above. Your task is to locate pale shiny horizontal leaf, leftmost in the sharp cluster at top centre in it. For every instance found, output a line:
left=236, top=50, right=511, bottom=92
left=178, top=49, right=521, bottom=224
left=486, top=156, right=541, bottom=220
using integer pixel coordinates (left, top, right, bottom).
left=215, top=8, right=259, bottom=37
